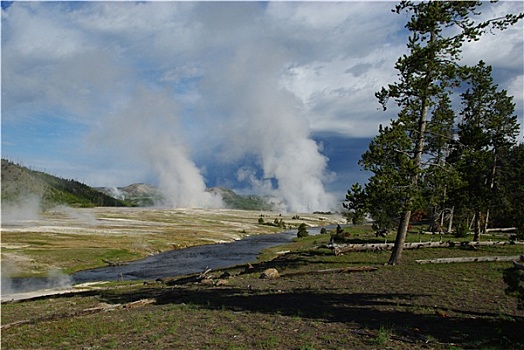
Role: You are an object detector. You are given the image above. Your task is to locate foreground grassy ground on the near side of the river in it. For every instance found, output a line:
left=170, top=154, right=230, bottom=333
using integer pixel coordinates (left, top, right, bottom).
left=2, top=209, right=524, bottom=350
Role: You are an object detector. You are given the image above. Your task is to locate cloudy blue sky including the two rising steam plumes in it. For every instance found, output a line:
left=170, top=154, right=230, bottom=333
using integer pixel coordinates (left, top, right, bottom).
left=1, top=1, right=524, bottom=211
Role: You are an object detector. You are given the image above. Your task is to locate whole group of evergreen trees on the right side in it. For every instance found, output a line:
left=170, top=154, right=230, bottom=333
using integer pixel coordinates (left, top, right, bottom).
left=343, top=1, right=524, bottom=264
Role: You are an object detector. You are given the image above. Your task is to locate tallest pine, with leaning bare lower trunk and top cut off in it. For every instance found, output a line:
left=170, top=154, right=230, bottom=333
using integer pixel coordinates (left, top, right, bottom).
left=350, top=1, right=522, bottom=264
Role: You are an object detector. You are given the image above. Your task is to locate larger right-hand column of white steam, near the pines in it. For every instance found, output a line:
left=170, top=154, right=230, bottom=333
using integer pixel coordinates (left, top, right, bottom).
left=199, top=42, right=336, bottom=212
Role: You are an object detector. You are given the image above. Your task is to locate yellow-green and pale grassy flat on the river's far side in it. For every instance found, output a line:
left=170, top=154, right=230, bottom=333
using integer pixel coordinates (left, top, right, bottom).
left=2, top=208, right=341, bottom=277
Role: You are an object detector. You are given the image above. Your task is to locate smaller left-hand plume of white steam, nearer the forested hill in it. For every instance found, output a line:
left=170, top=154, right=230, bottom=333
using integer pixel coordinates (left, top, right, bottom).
left=93, top=87, right=223, bottom=208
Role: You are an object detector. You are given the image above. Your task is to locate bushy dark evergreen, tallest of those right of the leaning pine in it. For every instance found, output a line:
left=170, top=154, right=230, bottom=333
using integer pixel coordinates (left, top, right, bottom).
left=455, top=61, right=519, bottom=241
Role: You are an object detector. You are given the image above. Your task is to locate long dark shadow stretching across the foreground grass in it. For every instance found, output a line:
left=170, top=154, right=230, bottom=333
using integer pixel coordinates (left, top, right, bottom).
left=98, top=286, right=524, bottom=349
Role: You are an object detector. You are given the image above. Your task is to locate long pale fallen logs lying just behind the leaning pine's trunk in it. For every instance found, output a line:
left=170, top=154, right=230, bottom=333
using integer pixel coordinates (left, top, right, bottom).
left=333, top=241, right=524, bottom=255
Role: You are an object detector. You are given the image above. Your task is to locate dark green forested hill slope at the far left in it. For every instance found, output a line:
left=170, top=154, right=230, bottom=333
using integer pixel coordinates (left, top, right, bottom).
left=1, top=159, right=130, bottom=207
